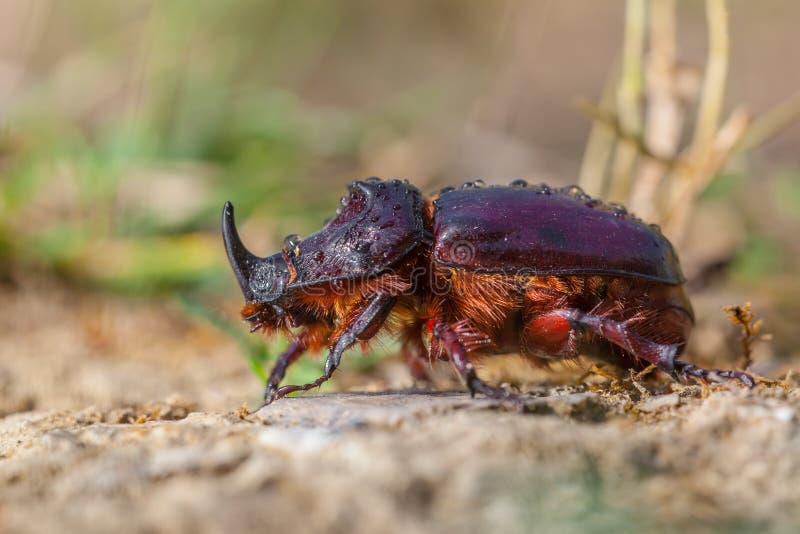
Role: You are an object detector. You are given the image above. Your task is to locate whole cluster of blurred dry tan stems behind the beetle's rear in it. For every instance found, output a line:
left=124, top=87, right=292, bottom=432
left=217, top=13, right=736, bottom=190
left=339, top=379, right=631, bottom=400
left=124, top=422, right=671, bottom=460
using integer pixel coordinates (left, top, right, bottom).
left=578, top=0, right=800, bottom=246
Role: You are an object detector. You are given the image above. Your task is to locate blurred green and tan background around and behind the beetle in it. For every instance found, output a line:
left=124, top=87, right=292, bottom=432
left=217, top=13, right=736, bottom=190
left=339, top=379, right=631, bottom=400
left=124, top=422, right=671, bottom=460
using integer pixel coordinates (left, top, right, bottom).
left=0, top=0, right=800, bottom=413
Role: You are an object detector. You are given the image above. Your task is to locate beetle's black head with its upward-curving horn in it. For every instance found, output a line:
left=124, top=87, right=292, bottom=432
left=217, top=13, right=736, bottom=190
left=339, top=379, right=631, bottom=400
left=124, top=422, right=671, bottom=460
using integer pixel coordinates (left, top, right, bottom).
left=222, top=202, right=290, bottom=308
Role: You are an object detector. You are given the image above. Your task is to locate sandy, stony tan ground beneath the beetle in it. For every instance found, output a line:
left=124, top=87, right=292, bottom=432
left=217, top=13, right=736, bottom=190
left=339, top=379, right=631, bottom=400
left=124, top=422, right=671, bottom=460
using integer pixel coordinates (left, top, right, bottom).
left=0, top=287, right=800, bottom=533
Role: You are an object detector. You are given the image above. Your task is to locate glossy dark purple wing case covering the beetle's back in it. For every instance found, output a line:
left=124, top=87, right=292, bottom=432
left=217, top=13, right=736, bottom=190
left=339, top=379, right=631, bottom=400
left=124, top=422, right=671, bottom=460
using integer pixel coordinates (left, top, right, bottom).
left=434, top=186, right=685, bottom=284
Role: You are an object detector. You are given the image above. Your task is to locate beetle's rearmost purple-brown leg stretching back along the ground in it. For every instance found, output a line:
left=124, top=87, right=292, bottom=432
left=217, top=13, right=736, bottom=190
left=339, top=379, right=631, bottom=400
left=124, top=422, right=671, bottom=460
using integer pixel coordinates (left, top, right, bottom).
left=540, top=309, right=755, bottom=387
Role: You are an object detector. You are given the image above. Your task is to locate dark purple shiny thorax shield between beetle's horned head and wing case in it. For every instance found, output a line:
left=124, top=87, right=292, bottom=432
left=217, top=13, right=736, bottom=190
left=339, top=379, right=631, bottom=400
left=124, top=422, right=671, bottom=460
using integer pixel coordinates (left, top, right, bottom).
left=288, top=178, right=424, bottom=288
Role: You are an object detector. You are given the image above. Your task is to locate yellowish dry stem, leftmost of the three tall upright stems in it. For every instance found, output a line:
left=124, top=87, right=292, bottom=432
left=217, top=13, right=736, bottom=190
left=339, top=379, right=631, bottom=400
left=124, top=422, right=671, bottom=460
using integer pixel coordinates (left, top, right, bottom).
left=609, top=0, right=646, bottom=201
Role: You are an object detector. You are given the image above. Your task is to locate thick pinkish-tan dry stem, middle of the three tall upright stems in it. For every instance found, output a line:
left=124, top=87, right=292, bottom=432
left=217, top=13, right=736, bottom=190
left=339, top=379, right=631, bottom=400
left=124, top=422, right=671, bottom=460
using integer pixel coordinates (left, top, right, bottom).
left=629, top=0, right=685, bottom=220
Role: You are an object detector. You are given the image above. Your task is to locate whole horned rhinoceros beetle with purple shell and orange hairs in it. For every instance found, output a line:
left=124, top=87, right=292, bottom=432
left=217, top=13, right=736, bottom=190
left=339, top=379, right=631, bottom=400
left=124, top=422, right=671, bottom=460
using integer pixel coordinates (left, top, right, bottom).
left=222, top=177, right=754, bottom=404
